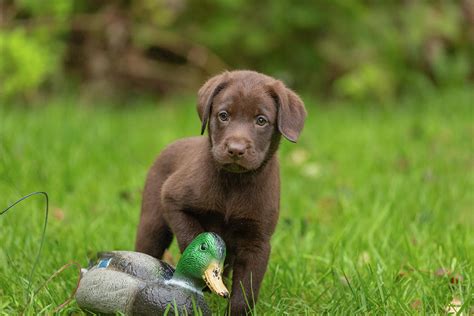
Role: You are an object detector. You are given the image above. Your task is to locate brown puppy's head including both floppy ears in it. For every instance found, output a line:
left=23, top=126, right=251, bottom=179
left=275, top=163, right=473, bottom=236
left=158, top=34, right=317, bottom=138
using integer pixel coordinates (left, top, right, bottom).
left=197, top=71, right=306, bottom=173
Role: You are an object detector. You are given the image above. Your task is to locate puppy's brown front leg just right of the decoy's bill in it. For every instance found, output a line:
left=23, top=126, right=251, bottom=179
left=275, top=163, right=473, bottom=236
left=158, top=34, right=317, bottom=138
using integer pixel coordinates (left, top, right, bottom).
left=230, top=242, right=270, bottom=315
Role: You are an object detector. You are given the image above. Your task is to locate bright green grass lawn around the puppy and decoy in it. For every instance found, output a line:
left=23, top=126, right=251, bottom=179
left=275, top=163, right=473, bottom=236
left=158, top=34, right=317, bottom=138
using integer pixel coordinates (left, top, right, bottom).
left=0, top=90, right=474, bottom=315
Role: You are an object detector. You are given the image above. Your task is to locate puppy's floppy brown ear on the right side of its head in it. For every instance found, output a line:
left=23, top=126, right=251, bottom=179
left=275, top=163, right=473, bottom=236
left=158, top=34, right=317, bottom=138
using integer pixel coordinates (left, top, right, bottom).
left=271, top=80, right=307, bottom=143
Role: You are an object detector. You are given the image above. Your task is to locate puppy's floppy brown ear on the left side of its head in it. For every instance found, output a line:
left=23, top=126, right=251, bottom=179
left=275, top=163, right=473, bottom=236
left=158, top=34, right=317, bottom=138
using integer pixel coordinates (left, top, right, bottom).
left=197, top=71, right=229, bottom=135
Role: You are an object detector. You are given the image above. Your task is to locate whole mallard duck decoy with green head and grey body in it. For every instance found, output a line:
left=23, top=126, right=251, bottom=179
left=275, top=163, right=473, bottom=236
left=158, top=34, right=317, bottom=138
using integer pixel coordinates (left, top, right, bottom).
left=76, top=233, right=229, bottom=315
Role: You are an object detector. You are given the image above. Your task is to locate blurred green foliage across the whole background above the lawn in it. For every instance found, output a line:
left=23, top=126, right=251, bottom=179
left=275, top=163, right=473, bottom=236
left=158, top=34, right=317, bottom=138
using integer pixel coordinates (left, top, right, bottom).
left=0, top=0, right=474, bottom=100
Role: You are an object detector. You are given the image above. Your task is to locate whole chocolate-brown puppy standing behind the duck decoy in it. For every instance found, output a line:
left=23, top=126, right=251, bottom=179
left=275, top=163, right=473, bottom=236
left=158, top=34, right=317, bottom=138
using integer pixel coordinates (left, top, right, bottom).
left=136, top=71, right=306, bottom=315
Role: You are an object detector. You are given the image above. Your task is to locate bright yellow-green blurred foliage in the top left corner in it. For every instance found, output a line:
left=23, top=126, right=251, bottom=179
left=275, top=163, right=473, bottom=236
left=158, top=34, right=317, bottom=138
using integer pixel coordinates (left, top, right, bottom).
left=0, top=0, right=73, bottom=100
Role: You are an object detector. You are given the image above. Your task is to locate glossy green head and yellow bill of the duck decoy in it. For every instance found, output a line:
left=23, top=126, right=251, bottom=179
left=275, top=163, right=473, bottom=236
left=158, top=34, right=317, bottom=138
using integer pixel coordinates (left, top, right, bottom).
left=173, top=232, right=229, bottom=297
